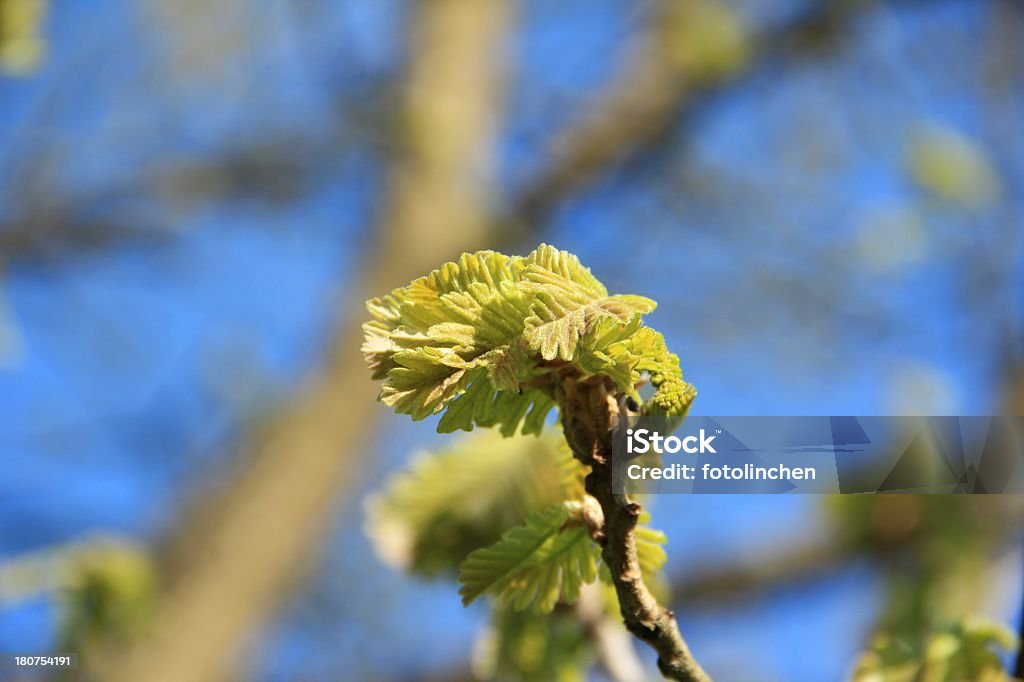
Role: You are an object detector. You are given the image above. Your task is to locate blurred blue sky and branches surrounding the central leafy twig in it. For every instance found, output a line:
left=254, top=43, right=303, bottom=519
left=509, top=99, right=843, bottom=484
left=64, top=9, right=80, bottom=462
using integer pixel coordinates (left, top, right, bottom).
left=0, top=0, right=1024, bottom=681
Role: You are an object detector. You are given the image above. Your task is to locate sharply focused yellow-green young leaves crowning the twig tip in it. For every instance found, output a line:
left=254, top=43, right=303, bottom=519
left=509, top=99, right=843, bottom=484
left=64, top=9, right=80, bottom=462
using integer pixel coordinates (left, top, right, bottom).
left=362, top=245, right=695, bottom=435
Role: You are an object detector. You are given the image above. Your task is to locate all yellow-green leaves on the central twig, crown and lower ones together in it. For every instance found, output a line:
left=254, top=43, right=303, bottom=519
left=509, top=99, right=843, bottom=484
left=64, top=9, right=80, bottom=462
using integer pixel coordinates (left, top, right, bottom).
left=362, top=245, right=695, bottom=680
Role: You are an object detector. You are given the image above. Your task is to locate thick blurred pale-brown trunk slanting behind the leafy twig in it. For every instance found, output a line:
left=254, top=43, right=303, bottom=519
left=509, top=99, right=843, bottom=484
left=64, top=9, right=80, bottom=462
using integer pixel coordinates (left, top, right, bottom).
left=89, top=0, right=510, bottom=682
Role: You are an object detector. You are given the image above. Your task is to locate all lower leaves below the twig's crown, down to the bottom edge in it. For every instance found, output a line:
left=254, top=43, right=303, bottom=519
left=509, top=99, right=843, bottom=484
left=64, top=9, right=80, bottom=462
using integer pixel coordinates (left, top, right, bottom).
left=367, top=429, right=666, bottom=682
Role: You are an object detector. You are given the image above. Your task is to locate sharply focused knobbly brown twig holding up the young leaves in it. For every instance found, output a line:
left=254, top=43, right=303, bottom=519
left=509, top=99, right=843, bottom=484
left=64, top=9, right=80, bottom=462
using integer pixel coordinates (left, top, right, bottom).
left=555, top=377, right=711, bottom=682
